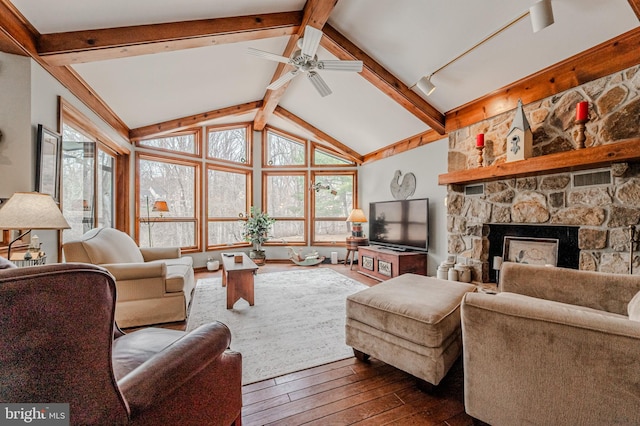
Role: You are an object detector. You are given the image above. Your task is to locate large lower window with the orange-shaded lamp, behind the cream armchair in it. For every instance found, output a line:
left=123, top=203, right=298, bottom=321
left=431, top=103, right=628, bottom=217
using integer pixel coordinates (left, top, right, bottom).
left=136, top=153, right=200, bottom=251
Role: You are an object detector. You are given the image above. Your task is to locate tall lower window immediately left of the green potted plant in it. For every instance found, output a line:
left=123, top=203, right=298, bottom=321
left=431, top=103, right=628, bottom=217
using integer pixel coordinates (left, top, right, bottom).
left=207, top=165, right=252, bottom=248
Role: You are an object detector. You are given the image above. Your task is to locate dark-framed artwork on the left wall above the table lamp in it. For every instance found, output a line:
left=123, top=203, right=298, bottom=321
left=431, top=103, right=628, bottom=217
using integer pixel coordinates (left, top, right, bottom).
left=36, top=124, right=62, bottom=202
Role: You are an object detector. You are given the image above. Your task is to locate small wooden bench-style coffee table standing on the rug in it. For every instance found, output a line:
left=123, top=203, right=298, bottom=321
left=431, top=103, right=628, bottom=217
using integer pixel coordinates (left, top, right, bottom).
left=222, top=253, right=258, bottom=309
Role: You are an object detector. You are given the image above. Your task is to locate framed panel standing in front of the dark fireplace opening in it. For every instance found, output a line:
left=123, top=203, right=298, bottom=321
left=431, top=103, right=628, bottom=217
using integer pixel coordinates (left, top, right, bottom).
left=503, top=237, right=558, bottom=266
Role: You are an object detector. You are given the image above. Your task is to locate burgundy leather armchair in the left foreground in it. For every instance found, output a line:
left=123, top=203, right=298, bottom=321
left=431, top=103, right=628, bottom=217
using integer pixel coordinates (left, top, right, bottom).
left=0, top=263, right=242, bottom=425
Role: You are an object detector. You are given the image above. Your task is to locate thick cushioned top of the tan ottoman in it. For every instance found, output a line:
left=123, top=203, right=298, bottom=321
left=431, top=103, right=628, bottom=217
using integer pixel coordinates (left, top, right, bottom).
left=347, top=274, right=476, bottom=348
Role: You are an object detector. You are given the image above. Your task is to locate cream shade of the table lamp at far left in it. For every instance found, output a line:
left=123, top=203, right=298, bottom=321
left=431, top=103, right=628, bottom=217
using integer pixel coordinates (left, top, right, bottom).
left=0, top=192, right=71, bottom=229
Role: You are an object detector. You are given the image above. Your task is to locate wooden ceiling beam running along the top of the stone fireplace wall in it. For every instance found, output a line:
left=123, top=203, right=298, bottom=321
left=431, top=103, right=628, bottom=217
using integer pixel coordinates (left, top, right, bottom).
left=446, top=27, right=640, bottom=132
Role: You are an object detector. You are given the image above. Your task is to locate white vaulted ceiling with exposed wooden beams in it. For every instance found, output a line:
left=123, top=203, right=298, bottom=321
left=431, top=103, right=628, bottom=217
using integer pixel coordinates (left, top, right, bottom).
left=0, top=0, right=640, bottom=162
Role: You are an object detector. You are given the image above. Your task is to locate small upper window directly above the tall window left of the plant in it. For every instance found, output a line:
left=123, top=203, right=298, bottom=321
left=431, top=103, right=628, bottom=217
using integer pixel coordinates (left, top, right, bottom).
left=207, top=124, right=251, bottom=164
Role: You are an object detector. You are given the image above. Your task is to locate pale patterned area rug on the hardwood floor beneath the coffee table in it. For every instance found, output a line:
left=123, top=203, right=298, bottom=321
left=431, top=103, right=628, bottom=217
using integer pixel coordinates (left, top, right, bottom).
left=187, top=267, right=367, bottom=385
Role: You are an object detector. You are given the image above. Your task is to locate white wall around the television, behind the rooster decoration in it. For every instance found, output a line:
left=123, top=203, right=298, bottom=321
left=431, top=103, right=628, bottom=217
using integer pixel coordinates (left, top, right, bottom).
left=358, top=138, right=449, bottom=276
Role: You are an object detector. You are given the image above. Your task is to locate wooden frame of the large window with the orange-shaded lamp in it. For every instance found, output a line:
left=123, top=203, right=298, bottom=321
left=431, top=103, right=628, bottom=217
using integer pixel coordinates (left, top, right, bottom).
left=134, top=151, right=202, bottom=253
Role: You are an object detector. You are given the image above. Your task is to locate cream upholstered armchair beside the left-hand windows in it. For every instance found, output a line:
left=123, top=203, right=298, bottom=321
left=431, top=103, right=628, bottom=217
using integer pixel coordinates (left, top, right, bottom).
left=62, top=228, right=195, bottom=327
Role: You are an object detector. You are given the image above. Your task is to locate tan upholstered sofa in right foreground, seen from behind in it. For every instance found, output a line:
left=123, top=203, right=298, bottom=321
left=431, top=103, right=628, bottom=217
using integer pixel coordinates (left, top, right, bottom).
left=461, top=263, right=640, bottom=426
